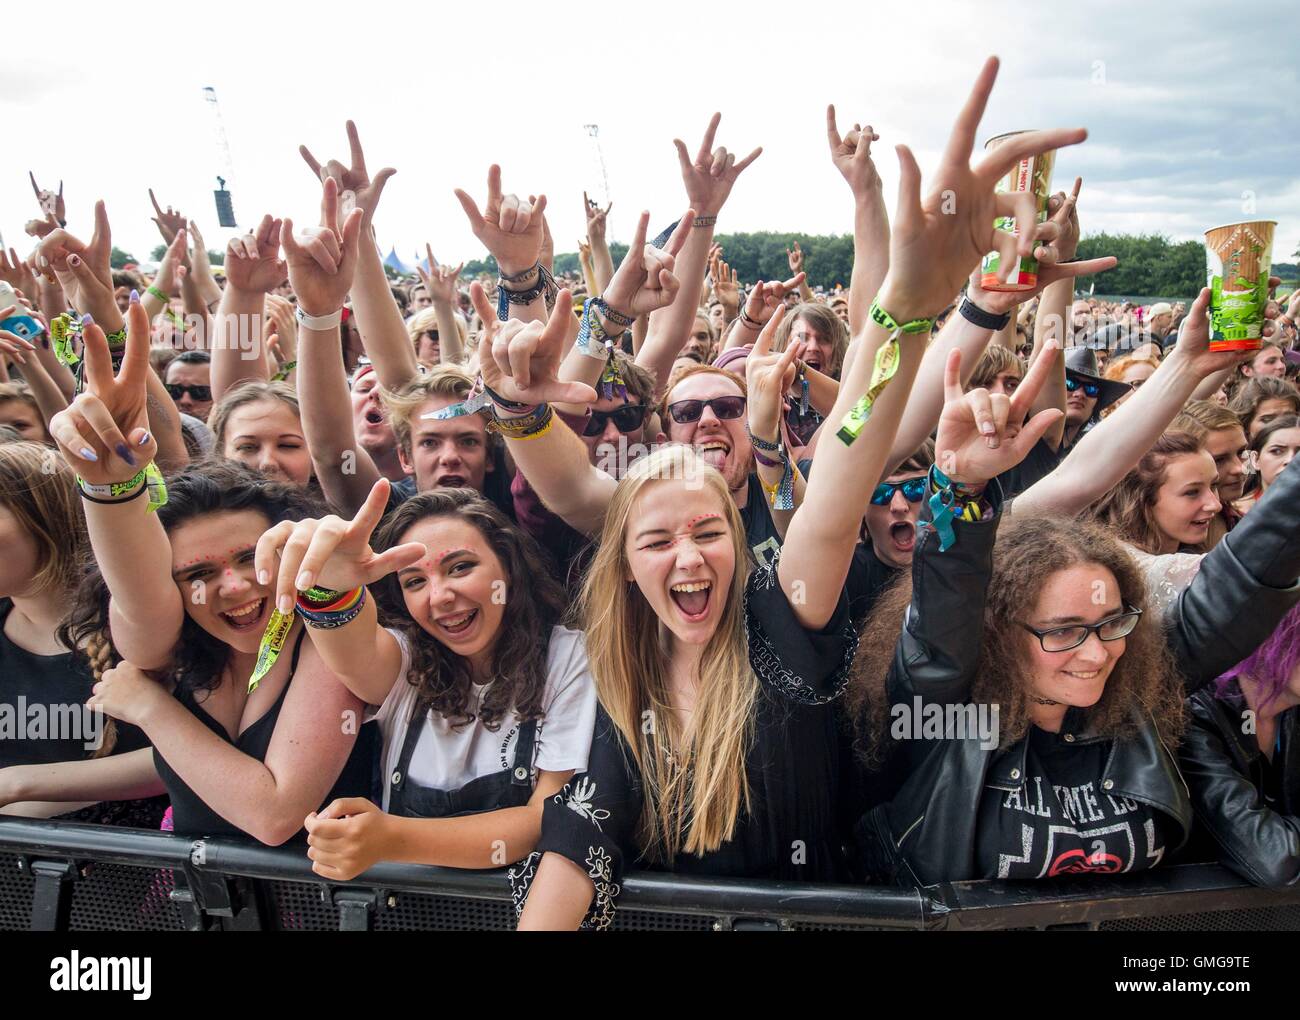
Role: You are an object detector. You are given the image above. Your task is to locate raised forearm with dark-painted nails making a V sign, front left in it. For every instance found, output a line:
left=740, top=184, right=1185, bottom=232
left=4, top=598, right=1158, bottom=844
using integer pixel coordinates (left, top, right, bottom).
left=49, top=299, right=185, bottom=669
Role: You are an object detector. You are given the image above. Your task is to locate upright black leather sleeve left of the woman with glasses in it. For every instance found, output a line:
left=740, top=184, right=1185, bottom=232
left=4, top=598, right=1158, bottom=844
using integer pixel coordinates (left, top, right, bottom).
left=889, top=481, right=1002, bottom=704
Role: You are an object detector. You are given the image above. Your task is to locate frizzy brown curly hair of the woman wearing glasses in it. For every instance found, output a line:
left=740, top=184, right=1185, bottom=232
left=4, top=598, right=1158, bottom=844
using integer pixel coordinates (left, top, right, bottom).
left=848, top=515, right=1184, bottom=767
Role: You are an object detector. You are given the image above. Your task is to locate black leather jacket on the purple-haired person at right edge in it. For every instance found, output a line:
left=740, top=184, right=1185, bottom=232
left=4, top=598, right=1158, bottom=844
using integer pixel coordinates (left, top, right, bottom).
left=1179, top=687, right=1300, bottom=886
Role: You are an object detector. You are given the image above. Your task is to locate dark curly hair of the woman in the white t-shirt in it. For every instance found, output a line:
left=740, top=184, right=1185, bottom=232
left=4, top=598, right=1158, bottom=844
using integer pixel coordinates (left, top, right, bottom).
left=374, top=489, right=567, bottom=730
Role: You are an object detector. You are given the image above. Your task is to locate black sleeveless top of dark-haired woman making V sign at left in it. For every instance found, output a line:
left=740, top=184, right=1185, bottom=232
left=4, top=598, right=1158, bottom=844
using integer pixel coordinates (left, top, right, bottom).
left=153, top=629, right=382, bottom=842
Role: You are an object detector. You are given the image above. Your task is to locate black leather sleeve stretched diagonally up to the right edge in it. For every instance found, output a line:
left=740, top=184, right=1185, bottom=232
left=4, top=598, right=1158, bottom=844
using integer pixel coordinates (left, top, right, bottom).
left=1165, top=461, right=1300, bottom=693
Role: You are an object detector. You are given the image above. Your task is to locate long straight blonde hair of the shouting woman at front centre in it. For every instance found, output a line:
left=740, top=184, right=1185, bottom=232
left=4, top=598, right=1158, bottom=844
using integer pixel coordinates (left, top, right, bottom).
left=580, top=444, right=758, bottom=864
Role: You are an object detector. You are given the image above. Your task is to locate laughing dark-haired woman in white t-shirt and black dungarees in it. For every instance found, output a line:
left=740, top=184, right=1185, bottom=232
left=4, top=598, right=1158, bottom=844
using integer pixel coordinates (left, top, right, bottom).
left=257, top=481, right=595, bottom=880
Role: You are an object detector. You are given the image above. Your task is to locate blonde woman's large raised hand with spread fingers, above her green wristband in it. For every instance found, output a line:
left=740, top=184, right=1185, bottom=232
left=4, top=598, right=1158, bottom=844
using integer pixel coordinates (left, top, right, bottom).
left=880, top=57, right=1088, bottom=322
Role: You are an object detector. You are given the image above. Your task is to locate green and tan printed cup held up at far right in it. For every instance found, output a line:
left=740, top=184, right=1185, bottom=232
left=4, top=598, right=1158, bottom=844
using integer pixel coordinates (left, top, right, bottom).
left=1205, top=220, right=1278, bottom=351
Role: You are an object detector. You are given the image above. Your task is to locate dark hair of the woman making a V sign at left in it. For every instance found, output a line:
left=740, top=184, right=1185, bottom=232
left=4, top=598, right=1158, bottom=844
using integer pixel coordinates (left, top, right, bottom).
left=60, top=461, right=325, bottom=691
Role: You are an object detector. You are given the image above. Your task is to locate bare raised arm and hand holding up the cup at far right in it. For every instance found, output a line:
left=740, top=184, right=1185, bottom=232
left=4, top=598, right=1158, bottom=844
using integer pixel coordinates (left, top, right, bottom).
left=1013, top=288, right=1248, bottom=515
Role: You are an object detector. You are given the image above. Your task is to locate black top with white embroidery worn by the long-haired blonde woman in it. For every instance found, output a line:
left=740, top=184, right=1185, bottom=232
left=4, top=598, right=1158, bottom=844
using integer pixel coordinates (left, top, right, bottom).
left=510, top=553, right=857, bottom=928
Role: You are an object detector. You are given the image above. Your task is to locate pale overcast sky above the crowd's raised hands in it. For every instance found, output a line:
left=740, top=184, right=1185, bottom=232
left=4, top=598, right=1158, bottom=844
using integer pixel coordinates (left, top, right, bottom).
left=0, top=0, right=1300, bottom=270
